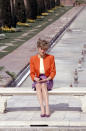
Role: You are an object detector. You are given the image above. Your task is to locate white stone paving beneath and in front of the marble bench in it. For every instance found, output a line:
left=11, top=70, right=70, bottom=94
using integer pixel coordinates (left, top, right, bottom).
left=0, top=96, right=86, bottom=128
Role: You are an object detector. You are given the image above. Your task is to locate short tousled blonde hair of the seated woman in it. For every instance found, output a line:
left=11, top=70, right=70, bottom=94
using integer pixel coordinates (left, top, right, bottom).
left=37, top=39, right=49, bottom=50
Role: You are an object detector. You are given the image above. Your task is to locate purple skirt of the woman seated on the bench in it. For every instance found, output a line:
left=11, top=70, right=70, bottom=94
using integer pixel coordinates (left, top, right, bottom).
left=32, top=74, right=53, bottom=91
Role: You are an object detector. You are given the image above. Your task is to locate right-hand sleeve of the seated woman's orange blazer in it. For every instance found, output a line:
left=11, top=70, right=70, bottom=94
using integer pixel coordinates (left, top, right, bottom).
left=50, top=56, right=56, bottom=79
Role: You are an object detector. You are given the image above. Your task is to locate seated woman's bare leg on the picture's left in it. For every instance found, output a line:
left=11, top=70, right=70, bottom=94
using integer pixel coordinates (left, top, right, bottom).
left=36, top=83, right=45, bottom=114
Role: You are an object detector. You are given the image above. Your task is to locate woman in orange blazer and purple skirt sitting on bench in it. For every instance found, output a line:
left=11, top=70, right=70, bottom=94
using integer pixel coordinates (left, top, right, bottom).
left=30, top=39, right=56, bottom=117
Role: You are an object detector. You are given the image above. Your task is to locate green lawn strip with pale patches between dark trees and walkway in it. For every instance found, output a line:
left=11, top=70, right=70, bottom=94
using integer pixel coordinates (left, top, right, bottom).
left=0, top=7, right=72, bottom=58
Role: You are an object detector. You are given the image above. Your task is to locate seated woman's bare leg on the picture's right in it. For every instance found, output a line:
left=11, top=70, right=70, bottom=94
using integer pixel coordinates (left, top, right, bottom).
left=42, top=83, right=50, bottom=115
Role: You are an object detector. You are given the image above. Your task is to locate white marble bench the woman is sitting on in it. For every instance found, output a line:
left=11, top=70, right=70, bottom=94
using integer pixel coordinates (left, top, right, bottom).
left=0, top=87, right=86, bottom=113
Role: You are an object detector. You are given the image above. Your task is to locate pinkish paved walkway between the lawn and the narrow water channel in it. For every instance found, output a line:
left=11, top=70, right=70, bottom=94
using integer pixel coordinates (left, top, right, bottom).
left=0, top=6, right=83, bottom=87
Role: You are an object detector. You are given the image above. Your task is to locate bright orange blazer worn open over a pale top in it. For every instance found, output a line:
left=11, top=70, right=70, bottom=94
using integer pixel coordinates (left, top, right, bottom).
left=30, top=54, right=56, bottom=80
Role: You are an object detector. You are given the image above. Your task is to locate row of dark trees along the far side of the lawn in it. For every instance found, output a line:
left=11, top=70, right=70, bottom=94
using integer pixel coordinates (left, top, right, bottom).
left=0, top=0, right=60, bottom=27
